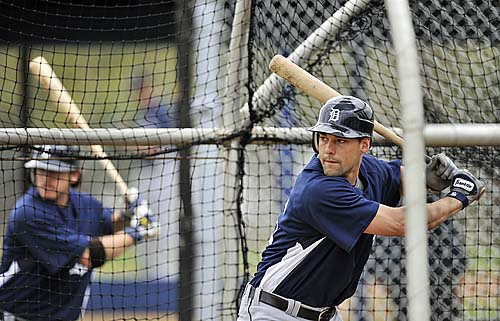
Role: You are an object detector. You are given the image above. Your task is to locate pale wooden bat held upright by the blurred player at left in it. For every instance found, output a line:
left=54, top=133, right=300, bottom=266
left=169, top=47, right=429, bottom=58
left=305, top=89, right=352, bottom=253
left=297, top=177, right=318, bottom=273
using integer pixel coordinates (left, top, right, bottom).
left=29, top=56, right=130, bottom=199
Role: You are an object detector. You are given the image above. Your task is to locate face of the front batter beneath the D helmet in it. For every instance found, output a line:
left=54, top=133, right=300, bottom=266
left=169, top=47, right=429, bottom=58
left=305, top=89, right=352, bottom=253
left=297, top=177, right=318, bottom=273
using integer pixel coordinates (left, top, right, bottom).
left=318, top=133, right=370, bottom=184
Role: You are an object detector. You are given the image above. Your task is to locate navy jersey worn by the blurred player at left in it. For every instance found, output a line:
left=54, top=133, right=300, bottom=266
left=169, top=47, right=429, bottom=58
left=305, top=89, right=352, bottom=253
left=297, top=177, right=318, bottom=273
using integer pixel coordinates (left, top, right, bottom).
left=0, top=187, right=113, bottom=320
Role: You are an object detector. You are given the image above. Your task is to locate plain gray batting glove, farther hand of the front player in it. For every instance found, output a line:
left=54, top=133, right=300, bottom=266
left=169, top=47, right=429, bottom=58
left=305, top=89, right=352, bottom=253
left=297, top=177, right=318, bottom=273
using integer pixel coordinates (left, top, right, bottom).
left=425, top=153, right=458, bottom=192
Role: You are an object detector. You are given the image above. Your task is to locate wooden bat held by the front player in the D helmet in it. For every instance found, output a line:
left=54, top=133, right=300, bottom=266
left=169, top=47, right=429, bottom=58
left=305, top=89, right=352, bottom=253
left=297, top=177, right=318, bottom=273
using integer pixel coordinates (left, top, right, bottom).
left=269, top=55, right=403, bottom=147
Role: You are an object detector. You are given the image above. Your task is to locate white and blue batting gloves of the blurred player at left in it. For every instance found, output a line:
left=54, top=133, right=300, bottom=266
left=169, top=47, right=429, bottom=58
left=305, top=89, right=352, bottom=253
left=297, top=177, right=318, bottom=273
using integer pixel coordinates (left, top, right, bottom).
left=125, top=188, right=160, bottom=242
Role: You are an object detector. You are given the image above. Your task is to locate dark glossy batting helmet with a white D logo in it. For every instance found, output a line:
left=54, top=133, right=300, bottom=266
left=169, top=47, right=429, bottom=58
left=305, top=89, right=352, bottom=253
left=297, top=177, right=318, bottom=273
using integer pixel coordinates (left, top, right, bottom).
left=308, top=96, right=374, bottom=153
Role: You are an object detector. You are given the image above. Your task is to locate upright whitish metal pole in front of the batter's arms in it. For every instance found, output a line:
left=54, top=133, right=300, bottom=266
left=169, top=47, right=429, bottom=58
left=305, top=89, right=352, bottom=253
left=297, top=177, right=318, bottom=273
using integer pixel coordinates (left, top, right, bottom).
left=385, top=0, right=430, bottom=321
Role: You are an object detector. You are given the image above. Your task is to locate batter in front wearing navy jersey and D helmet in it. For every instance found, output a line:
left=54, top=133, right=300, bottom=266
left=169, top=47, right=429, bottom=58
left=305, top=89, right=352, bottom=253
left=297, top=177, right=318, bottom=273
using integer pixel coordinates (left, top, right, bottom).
left=238, top=96, right=484, bottom=321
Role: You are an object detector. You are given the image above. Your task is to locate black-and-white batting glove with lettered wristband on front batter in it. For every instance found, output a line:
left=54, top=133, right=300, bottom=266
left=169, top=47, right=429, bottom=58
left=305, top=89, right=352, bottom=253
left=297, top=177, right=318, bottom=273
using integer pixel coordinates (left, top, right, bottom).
left=446, top=170, right=486, bottom=209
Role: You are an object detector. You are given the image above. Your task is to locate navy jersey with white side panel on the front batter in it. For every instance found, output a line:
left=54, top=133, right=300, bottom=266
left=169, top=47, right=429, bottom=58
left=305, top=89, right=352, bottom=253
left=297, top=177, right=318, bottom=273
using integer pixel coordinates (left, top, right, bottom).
left=250, top=155, right=401, bottom=307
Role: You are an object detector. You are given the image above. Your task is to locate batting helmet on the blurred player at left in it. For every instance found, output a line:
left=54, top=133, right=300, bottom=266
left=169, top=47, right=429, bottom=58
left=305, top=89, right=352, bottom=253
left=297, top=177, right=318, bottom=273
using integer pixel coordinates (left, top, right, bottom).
left=24, top=145, right=80, bottom=172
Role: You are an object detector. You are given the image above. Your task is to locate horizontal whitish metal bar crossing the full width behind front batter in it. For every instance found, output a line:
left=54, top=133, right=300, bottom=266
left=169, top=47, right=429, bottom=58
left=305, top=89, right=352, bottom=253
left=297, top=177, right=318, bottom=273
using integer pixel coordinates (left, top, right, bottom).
left=0, top=123, right=500, bottom=147
